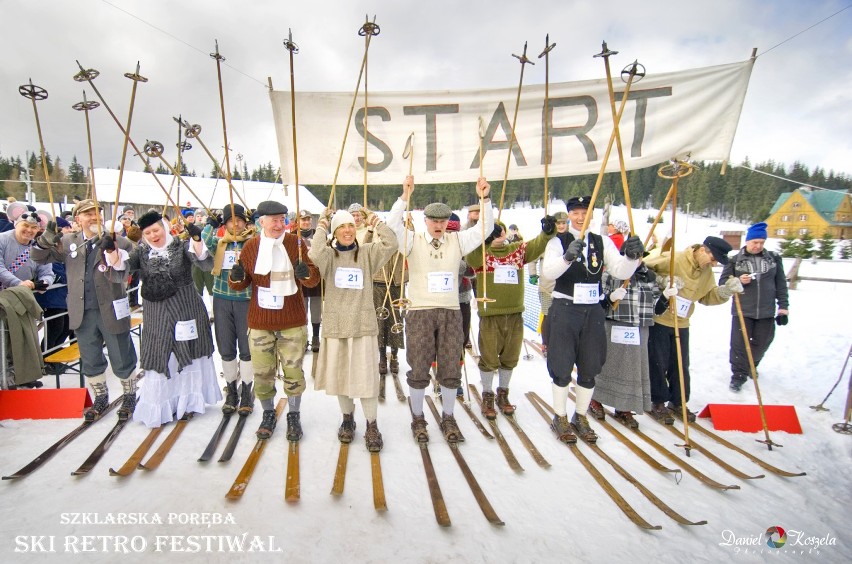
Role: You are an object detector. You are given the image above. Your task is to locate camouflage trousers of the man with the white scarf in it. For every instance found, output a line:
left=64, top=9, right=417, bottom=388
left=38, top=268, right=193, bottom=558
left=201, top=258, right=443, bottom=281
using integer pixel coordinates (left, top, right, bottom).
left=249, top=325, right=308, bottom=400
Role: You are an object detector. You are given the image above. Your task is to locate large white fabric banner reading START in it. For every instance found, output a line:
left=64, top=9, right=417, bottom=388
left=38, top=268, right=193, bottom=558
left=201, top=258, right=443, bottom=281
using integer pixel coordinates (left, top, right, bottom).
left=270, top=59, right=755, bottom=185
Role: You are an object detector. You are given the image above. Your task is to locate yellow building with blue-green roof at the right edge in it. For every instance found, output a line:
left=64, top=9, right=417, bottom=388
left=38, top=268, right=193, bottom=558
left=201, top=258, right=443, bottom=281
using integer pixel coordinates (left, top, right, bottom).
left=766, top=187, right=852, bottom=239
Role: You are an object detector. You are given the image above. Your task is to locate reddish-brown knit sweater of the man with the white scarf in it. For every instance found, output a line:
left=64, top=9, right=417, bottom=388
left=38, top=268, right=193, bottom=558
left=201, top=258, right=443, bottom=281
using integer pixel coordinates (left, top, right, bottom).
left=228, top=233, right=320, bottom=331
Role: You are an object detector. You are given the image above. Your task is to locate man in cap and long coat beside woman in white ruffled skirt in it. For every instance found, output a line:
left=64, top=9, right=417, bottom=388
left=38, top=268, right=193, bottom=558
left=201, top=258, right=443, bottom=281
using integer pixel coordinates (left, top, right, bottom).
left=31, top=200, right=137, bottom=421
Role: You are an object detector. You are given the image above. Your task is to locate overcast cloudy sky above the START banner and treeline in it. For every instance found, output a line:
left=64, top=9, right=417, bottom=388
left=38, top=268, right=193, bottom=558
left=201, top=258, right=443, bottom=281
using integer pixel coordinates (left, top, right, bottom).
left=0, top=0, right=852, bottom=185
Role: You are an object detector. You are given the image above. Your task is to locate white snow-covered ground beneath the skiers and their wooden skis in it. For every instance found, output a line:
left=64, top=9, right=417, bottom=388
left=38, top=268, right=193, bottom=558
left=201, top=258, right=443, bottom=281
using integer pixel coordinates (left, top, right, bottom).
left=0, top=209, right=852, bottom=563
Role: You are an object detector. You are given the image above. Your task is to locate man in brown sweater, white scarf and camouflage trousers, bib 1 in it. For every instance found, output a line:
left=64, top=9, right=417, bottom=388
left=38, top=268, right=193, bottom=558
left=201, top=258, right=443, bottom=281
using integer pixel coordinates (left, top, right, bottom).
left=228, top=200, right=320, bottom=441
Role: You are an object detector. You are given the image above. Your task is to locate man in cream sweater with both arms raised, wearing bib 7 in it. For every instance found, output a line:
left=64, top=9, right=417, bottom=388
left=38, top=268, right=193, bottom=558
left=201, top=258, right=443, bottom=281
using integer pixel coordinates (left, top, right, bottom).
left=388, top=176, right=494, bottom=442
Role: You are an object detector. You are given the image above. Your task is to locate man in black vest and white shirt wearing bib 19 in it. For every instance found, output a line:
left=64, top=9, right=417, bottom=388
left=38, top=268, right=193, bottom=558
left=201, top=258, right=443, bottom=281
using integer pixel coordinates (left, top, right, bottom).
left=542, top=196, right=644, bottom=443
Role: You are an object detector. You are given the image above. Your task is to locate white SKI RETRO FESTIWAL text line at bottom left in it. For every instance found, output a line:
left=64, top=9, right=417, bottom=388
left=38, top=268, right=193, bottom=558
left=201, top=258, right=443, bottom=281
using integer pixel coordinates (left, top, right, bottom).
left=15, top=533, right=284, bottom=554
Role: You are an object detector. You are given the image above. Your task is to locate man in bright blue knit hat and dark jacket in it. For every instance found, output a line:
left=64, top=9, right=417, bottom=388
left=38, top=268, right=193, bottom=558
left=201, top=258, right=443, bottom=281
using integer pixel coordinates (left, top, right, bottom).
left=719, top=222, right=790, bottom=392
